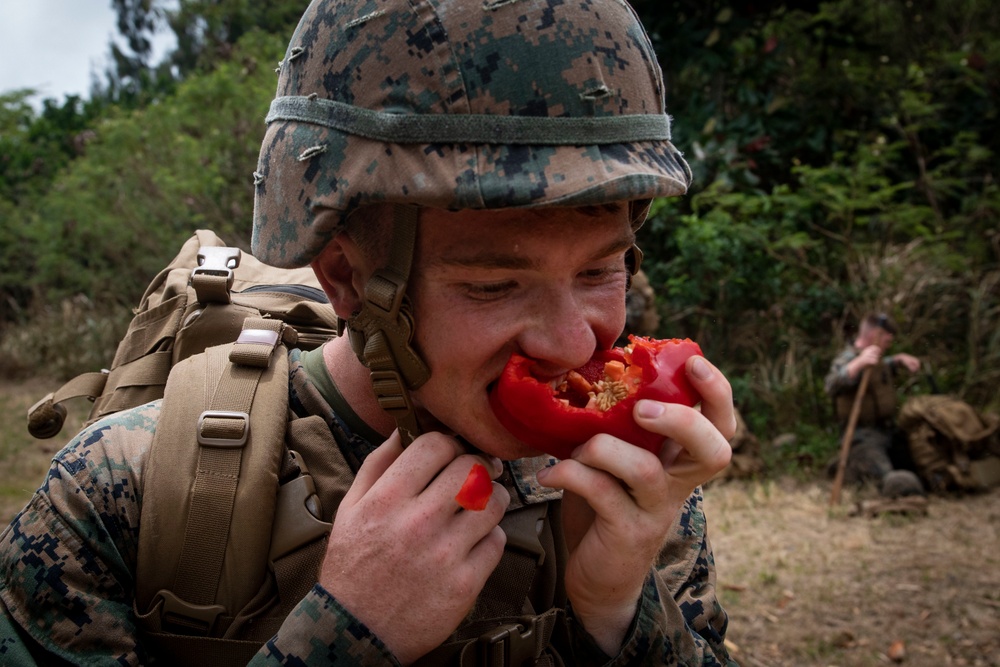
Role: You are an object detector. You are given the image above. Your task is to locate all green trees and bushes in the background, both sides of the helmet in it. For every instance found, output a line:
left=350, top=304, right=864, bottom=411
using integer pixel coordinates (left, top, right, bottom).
left=0, top=0, right=1000, bottom=478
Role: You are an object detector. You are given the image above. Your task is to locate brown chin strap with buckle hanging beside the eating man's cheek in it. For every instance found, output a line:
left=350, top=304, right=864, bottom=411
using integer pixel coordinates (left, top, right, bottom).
left=347, top=205, right=430, bottom=447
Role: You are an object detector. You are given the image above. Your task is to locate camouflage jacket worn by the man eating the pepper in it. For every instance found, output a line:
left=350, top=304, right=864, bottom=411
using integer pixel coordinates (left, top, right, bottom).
left=0, top=351, right=734, bottom=666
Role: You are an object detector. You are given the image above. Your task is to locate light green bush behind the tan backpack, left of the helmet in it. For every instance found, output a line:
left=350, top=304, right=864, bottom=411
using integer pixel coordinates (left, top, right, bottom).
left=8, top=33, right=282, bottom=312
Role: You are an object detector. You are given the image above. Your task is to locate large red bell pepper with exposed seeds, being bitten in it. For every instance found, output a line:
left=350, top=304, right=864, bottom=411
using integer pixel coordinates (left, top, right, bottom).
left=490, top=336, right=701, bottom=458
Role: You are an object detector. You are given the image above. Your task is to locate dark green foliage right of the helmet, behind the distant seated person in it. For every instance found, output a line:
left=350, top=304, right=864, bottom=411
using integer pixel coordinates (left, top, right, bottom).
left=636, top=0, right=1000, bottom=451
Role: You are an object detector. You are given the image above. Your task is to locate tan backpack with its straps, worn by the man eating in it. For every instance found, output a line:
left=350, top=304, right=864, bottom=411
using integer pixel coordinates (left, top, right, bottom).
left=28, top=231, right=566, bottom=667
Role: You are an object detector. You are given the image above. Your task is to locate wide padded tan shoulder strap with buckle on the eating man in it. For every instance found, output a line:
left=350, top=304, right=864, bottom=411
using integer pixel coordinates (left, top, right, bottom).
left=136, top=318, right=294, bottom=635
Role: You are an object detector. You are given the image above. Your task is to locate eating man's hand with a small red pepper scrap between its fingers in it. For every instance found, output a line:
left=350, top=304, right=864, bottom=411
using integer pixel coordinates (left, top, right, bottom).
left=320, top=433, right=510, bottom=665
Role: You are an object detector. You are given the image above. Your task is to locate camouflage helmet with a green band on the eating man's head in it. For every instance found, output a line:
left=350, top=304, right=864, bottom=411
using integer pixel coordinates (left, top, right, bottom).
left=253, top=0, right=690, bottom=267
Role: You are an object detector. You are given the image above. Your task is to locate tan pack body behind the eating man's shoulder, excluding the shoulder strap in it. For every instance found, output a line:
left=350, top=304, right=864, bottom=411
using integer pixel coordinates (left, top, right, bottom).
left=28, top=230, right=337, bottom=438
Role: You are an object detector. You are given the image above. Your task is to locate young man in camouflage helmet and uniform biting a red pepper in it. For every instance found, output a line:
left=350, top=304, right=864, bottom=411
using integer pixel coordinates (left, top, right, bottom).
left=0, top=0, right=735, bottom=665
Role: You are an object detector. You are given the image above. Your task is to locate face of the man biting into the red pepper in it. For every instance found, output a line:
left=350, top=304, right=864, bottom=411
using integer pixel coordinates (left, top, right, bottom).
left=408, top=205, right=634, bottom=459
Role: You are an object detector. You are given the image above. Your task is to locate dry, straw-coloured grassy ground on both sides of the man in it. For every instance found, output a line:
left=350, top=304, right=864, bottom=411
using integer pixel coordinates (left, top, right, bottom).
left=0, top=381, right=1000, bottom=667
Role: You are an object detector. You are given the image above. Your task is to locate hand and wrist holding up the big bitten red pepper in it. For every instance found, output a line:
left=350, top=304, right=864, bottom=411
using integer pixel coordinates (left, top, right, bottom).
left=538, top=357, right=736, bottom=655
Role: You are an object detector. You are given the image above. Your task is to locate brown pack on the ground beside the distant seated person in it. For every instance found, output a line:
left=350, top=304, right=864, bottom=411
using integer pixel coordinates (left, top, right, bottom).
left=897, top=395, right=1000, bottom=493
